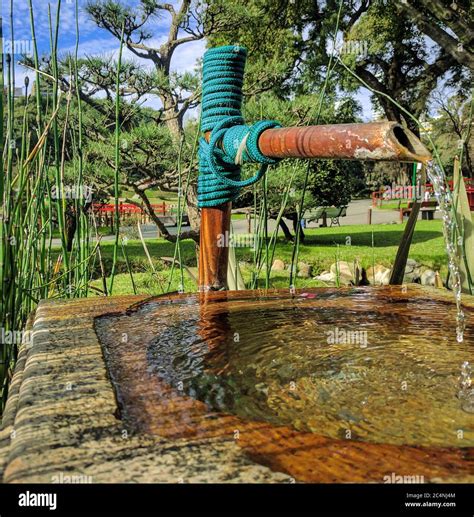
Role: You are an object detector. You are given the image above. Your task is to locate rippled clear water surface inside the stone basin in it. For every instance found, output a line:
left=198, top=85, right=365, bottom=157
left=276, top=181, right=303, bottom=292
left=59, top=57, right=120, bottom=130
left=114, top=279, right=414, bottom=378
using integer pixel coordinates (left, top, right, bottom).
left=98, top=288, right=474, bottom=447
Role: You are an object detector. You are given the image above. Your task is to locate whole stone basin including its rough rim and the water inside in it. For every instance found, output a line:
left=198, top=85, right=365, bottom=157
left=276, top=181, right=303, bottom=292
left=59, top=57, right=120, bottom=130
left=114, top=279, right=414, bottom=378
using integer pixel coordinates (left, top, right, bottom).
left=0, top=285, right=474, bottom=482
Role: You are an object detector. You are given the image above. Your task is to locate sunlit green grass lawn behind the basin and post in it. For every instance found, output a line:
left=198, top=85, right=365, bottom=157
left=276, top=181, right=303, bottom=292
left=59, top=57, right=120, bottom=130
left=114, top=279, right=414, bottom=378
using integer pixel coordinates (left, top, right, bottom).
left=87, top=221, right=446, bottom=295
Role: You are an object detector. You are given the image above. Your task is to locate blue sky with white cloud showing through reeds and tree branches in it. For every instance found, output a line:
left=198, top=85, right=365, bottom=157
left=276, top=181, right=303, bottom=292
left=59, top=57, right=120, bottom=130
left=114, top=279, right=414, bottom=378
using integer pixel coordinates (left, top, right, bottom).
left=0, top=0, right=373, bottom=120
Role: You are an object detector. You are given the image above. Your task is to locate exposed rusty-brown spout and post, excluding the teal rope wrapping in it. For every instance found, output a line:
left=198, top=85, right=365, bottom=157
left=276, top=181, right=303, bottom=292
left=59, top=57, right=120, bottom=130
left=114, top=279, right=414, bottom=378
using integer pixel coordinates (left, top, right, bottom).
left=199, top=121, right=431, bottom=290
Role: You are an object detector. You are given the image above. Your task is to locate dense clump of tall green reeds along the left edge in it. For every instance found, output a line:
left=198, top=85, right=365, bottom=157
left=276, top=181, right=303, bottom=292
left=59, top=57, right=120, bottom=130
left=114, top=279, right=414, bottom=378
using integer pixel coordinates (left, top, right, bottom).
left=0, top=0, right=99, bottom=413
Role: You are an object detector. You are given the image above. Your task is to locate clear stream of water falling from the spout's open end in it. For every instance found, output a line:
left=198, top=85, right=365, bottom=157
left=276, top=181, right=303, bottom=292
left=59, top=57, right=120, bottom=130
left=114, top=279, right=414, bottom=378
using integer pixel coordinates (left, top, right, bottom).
left=426, top=160, right=465, bottom=343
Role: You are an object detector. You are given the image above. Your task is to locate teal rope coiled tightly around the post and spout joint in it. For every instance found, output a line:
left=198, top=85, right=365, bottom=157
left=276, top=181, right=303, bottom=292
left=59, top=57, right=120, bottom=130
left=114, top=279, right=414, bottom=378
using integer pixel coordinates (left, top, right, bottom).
left=198, top=46, right=280, bottom=207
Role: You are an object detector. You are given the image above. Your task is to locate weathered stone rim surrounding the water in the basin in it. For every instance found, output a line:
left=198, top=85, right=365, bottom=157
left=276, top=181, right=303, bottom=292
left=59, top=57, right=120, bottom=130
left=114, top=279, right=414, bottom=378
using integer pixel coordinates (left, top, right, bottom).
left=0, top=285, right=474, bottom=483
